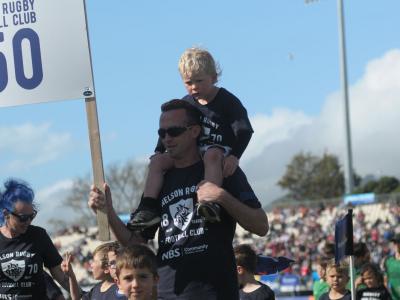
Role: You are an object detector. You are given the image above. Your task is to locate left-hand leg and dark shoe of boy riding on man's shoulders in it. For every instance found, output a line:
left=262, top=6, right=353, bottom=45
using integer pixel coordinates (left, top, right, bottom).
left=128, top=153, right=173, bottom=230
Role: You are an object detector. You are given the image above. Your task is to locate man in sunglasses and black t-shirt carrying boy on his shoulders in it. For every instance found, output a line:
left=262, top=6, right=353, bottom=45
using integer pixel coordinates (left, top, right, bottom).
left=89, top=100, right=268, bottom=300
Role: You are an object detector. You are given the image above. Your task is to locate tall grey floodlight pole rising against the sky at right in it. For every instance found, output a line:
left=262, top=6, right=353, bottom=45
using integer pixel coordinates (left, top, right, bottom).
left=337, top=0, right=354, bottom=194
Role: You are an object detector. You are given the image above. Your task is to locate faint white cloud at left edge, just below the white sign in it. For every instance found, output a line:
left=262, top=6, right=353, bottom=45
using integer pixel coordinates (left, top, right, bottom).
left=0, top=123, right=72, bottom=174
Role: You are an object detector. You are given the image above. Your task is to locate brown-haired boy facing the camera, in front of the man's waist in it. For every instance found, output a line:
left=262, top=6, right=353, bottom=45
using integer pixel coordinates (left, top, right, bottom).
left=116, top=245, right=158, bottom=300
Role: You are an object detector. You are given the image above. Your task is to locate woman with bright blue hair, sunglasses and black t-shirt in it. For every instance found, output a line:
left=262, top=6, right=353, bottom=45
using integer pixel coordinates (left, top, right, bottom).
left=0, top=179, right=69, bottom=300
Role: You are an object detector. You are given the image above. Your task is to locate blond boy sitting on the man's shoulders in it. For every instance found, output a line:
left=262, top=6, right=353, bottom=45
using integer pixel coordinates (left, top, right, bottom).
left=129, top=48, right=253, bottom=226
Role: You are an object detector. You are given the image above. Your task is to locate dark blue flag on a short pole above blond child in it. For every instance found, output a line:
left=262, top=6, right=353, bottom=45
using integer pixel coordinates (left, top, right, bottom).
left=335, top=209, right=353, bottom=263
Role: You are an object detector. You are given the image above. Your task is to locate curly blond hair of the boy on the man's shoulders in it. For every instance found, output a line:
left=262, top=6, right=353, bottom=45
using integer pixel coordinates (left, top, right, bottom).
left=178, top=47, right=221, bottom=79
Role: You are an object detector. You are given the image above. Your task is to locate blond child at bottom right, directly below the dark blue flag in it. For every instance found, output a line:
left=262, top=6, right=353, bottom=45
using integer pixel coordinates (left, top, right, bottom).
left=319, top=261, right=351, bottom=300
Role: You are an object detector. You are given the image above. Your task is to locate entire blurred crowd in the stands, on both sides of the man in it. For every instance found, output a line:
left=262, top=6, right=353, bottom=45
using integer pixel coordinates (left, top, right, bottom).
left=48, top=202, right=400, bottom=294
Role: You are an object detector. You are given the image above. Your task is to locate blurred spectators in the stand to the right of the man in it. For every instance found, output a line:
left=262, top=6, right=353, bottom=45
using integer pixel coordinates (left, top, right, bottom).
left=237, top=201, right=400, bottom=287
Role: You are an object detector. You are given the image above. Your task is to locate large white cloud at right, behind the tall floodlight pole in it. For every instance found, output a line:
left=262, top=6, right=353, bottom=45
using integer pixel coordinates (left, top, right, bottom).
left=243, top=49, right=400, bottom=203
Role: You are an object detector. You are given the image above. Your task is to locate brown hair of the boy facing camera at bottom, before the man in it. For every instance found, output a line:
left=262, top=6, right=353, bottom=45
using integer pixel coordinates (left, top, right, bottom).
left=116, top=245, right=158, bottom=276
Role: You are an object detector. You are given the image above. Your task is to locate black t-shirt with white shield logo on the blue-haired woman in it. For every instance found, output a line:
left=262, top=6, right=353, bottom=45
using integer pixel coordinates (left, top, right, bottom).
left=0, top=225, right=62, bottom=300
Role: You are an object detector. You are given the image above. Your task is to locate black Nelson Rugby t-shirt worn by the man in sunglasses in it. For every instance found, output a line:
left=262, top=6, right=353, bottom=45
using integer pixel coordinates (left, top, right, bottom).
left=152, top=161, right=261, bottom=299
